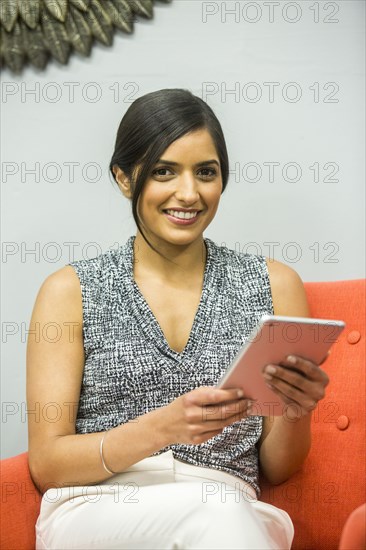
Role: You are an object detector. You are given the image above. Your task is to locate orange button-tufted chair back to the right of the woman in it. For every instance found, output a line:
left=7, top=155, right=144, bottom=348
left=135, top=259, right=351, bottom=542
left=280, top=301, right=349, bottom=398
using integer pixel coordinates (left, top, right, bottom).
left=262, top=280, right=366, bottom=550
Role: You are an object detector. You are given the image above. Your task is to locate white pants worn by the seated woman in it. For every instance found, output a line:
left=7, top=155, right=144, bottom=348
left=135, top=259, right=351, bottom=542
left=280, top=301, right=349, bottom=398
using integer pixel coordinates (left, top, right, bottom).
left=36, top=450, right=294, bottom=550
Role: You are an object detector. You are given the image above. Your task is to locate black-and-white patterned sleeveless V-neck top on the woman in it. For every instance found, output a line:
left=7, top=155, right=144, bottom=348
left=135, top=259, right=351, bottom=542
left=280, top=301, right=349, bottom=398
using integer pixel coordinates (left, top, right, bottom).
left=67, top=236, right=273, bottom=495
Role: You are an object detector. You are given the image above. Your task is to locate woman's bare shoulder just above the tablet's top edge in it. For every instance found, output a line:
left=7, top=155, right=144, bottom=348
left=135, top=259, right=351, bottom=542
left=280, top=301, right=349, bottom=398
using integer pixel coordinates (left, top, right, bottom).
left=266, top=258, right=309, bottom=317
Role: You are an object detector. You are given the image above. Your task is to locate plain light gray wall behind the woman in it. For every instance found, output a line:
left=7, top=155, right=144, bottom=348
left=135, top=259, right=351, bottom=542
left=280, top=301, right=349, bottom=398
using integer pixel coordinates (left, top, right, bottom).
left=1, top=0, right=365, bottom=457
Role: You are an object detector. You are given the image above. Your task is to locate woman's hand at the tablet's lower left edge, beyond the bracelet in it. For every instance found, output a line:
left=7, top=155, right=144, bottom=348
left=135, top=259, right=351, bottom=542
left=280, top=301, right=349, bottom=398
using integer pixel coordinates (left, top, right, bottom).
left=159, top=386, right=253, bottom=445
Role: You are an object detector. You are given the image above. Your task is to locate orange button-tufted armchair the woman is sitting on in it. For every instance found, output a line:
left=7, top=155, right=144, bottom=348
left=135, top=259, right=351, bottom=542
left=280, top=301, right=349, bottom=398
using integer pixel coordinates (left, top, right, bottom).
left=1, top=279, right=366, bottom=550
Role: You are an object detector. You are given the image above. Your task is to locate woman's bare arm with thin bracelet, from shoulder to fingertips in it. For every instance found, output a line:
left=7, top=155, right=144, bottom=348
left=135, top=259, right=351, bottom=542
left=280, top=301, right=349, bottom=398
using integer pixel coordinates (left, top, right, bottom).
left=27, top=266, right=252, bottom=493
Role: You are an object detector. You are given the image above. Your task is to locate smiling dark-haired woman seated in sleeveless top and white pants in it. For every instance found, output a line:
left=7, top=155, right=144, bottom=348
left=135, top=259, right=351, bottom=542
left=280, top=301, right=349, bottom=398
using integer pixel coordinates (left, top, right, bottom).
left=27, top=89, right=328, bottom=549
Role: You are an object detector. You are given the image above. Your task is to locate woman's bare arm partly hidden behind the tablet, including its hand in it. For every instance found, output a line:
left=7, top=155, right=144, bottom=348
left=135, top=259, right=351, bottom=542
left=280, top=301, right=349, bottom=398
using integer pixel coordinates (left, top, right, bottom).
left=259, top=261, right=328, bottom=484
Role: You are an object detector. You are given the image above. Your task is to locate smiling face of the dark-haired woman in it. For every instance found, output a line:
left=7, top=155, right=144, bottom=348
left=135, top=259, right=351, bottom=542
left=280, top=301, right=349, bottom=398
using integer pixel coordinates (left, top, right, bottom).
left=138, top=129, right=222, bottom=249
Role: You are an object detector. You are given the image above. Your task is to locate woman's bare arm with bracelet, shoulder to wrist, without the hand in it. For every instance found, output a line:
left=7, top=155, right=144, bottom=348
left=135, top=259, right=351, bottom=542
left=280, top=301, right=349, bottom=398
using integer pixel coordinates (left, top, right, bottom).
left=27, top=267, right=172, bottom=491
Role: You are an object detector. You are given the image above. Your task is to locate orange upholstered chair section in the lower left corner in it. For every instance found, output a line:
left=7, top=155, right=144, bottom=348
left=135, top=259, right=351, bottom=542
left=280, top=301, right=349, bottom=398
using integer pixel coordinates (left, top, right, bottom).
left=1, top=453, right=42, bottom=550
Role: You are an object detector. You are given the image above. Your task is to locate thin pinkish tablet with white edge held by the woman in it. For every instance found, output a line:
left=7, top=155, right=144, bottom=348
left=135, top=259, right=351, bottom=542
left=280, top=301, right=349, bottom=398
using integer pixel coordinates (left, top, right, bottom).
left=217, top=315, right=345, bottom=416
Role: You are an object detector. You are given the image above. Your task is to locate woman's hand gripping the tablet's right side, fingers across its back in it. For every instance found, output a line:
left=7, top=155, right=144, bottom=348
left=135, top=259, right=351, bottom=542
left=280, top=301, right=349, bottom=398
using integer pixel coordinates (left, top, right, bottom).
left=263, top=355, right=329, bottom=417
